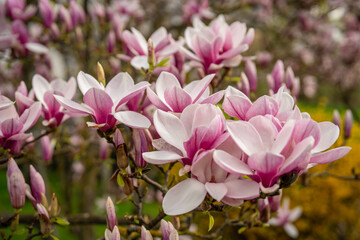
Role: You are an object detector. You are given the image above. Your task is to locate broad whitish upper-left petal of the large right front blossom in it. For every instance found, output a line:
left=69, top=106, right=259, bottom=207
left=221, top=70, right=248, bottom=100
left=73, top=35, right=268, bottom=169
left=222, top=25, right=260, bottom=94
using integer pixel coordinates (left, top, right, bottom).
left=227, top=121, right=264, bottom=156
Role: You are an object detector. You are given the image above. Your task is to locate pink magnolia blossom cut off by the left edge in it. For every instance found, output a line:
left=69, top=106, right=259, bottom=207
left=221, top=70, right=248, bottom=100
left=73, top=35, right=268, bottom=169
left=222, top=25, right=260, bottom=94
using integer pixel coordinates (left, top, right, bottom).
left=0, top=96, right=41, bottom=153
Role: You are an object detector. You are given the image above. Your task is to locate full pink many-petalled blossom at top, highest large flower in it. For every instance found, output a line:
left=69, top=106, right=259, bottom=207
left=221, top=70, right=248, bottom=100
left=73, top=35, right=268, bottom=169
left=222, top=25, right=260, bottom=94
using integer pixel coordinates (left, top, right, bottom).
left=182, top=15, right=254, bottom=74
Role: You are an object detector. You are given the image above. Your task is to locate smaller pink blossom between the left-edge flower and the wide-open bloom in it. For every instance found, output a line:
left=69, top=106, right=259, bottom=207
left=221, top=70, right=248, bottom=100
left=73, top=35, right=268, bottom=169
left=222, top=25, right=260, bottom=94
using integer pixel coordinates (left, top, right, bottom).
left=32, top=74, right=76, bottom=127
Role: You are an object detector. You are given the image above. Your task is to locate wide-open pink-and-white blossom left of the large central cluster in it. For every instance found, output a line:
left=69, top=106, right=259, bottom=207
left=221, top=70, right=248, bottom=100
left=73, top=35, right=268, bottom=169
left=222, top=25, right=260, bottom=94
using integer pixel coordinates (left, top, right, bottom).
left=55, top=72, right=151, bottom=131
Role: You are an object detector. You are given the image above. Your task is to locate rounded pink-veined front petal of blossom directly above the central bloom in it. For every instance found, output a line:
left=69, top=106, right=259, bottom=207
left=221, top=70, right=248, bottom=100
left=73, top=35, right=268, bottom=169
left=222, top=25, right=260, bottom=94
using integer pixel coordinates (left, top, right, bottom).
left=164, top=86, right=192, bottom=113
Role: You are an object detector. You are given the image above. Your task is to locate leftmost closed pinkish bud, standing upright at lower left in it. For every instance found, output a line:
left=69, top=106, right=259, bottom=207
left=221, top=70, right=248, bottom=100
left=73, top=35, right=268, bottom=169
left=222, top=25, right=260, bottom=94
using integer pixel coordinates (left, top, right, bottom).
left=6, top=158, right=26, bottom=209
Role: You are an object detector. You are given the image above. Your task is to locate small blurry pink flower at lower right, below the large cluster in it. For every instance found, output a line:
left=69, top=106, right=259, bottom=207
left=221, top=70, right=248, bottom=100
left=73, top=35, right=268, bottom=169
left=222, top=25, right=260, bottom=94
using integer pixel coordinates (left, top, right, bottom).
left=268, top=198, right=302, bottom=238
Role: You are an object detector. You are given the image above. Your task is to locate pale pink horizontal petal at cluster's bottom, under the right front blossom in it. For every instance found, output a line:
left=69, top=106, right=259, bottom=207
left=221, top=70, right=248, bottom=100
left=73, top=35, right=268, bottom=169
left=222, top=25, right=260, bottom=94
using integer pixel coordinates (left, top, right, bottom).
left=225, top=179, right=260, bottom=200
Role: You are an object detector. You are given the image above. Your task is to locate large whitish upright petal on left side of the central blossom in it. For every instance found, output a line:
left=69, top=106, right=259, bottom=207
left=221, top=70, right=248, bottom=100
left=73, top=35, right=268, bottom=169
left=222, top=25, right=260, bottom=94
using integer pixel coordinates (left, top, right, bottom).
left=154, top=110, right=189, bottom=152
